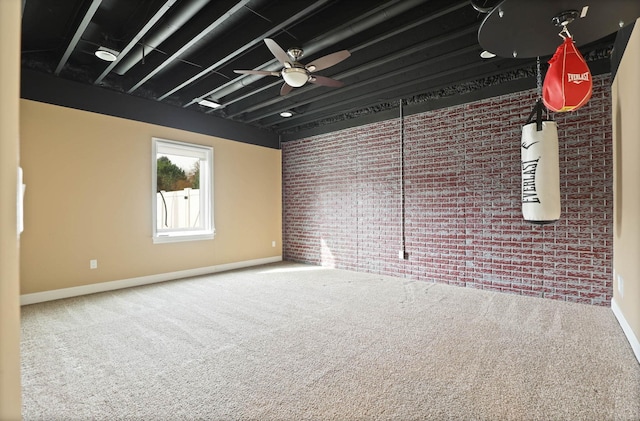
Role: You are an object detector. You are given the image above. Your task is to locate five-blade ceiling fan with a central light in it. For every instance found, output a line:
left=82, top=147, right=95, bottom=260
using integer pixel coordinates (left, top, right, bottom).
left=234, top=38, right=351, bottom=95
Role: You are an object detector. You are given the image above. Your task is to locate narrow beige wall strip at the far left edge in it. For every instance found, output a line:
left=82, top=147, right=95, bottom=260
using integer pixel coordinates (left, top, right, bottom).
left=0, top=0, right=22, bottom=420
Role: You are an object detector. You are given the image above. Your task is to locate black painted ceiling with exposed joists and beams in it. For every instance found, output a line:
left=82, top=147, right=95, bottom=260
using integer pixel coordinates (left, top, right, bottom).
left=22, top=0, right=615, bottom=143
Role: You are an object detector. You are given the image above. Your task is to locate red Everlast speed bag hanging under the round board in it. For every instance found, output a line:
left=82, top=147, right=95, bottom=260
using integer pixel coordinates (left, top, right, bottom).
left=542, top=37, right=593, bottom=112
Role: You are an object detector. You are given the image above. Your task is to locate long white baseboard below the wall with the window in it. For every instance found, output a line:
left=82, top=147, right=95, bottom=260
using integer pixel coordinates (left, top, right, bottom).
left=20, top=256, right=282, bottom=306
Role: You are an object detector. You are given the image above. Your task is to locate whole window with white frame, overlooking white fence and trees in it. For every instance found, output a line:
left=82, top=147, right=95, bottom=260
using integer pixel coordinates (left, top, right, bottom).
left=151, top=138, right=215, bottom=243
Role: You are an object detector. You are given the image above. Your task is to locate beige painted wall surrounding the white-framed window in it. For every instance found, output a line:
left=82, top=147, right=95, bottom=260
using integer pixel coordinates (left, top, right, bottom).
left=20, top=100, right=282, bottom=294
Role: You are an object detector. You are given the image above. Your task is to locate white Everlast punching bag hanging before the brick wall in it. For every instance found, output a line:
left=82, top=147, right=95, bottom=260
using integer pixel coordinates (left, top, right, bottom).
left=520, top=100, right=560, bottom=224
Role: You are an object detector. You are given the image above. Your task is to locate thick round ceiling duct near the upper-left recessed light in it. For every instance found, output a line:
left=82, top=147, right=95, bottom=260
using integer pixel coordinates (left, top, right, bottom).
left=113, top=0, right=211, bottom=75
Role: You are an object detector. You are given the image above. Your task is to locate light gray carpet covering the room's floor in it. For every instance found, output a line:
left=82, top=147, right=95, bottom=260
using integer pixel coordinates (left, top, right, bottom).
left=22, top=262, right=640, bottom=420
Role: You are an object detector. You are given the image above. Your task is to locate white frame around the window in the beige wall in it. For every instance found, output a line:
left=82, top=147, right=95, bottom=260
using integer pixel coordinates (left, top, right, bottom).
left=151, top=137, right=215, bottom=244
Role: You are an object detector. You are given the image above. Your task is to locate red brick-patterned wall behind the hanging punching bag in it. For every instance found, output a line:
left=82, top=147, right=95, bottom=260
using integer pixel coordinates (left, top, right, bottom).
left=282, top=75, right=613, bottom=305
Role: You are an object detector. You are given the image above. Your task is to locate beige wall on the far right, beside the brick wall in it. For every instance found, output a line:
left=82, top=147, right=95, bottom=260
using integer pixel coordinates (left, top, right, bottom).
left=612, top=19, right=640, bottom=352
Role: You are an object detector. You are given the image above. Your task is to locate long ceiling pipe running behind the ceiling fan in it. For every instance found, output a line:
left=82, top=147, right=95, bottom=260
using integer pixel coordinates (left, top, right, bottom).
left=209, top=0, right=426, bottom=102
